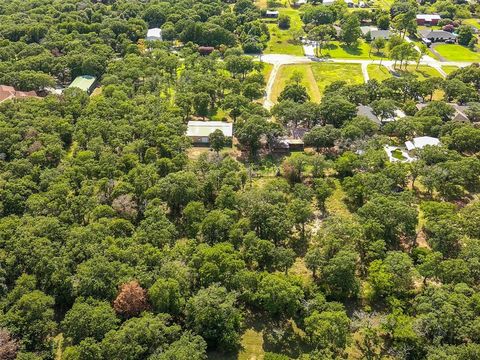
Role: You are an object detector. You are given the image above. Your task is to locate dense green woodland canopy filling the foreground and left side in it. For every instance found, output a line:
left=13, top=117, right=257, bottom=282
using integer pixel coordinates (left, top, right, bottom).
left=0, top=0, right=480, bottom=360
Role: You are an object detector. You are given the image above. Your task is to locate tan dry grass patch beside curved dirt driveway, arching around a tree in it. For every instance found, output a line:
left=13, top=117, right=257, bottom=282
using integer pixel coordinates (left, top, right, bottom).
left=272, top=64, right=321, bottom=102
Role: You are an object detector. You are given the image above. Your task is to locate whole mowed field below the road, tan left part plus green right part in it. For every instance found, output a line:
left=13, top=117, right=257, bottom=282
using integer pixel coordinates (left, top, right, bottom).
left=272, top=63, right=363, bottom=102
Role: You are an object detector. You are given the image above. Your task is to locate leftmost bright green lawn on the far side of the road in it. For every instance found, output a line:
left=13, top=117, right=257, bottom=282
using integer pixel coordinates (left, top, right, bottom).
left=264, top=8, right=303, bottom=56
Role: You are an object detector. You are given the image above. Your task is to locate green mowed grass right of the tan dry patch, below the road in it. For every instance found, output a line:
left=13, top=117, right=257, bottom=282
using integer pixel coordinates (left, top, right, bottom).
left=311, top=63, right=363, bottom=94
